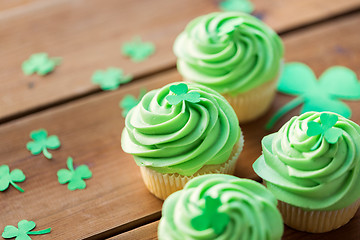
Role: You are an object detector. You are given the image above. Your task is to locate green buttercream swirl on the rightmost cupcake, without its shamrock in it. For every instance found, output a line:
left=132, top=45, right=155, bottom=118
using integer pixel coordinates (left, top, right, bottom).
left=253, top=112, right=360, bottom=210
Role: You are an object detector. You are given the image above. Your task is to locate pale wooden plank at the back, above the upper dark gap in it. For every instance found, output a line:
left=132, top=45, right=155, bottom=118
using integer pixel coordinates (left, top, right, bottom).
left=0, top=0, right=360, bottom=120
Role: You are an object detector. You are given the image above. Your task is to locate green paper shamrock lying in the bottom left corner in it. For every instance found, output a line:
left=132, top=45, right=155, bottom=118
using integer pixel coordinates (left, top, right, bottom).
left=2, top=220, right=51, bottom=240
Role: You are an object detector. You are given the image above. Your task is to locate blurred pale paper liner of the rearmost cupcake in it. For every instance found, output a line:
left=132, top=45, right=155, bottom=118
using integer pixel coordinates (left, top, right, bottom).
left=222, top=77, right=278, bottom=123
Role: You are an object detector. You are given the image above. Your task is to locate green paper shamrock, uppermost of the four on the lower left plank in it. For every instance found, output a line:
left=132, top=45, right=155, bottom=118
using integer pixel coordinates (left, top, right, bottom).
left=26, top=129, right=60, bottom=159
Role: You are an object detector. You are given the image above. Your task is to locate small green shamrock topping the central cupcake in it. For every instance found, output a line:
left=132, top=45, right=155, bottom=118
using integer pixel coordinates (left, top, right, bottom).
left=166, top=83, right=200, bottom=105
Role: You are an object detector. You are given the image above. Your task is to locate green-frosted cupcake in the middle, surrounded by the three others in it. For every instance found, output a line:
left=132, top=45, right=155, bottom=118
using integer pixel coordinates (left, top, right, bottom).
left=121, top=83, right=243, bottom=199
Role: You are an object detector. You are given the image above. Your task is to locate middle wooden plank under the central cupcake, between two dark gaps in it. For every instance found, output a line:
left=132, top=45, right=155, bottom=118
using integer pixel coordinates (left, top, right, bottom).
left=0, top=11, right=360, bottom=239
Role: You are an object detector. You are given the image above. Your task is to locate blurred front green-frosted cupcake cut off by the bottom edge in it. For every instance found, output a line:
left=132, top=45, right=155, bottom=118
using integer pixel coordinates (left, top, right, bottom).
left=158, top=174, right=284, bottom=240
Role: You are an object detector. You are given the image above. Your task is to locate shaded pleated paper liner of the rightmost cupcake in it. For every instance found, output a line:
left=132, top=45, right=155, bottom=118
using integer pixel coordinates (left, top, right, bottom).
left=278, top=199, right=360, bottom=233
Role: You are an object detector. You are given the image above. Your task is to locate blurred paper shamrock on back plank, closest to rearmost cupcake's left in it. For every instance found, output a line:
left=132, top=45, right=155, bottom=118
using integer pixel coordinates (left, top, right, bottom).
left=121, top=37, right=155, bottom=62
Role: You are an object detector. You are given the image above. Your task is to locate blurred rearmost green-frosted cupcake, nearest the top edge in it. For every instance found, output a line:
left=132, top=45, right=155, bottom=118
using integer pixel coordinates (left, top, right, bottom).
left=174, top=12, right=284, bottom=123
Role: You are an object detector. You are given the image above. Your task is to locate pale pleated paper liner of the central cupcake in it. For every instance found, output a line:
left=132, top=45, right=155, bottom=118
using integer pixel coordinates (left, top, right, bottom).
left=140, top=136, right=244, bottom=200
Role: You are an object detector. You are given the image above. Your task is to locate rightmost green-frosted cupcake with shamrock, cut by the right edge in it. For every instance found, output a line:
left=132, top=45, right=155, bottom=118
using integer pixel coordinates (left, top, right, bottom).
left=253, top=112, right=360, bottom=233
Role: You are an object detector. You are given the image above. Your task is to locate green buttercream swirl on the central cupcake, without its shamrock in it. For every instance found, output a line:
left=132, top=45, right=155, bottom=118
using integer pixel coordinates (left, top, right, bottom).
left=121, top=83, right=241, bottom=176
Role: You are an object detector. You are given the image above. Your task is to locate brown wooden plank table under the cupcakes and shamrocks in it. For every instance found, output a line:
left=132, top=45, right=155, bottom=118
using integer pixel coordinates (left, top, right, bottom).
left=0, top=0, right=360, bottom=240
